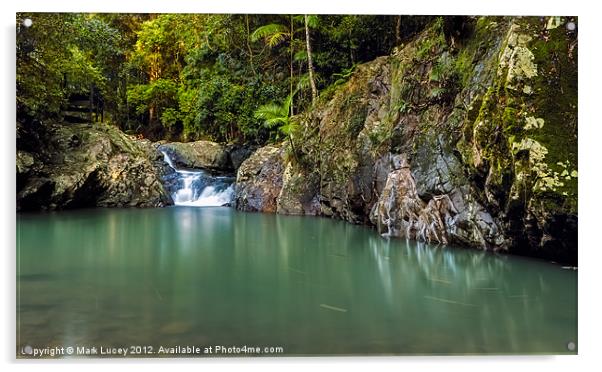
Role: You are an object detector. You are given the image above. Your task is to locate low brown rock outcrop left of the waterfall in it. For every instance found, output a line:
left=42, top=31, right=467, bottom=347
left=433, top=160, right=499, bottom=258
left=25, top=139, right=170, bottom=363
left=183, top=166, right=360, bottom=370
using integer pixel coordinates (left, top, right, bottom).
left=17, top=124, right=171, bottom=210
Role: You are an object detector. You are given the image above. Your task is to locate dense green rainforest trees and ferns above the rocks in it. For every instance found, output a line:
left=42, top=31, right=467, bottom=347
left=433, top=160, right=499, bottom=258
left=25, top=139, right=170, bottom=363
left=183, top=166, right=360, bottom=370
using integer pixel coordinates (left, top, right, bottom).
left=17, top=13, right=429, bottom=143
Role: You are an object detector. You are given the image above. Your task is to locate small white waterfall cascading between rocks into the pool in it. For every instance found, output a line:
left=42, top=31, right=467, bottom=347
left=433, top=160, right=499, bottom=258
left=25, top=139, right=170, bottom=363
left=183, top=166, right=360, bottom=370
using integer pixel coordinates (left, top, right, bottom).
left=160, top=149, right=234, bottom=207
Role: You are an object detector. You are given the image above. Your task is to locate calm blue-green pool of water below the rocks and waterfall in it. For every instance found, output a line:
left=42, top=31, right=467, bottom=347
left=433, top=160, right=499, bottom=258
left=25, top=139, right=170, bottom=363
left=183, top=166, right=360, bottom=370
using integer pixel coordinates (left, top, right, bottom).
left=17, top=207, right=577, bottom=355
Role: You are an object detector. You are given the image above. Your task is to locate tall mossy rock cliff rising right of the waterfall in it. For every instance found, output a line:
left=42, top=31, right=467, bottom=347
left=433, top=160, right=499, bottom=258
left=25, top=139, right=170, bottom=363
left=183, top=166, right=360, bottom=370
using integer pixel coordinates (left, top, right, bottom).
left=232, top=17, right=578, bottom=264
